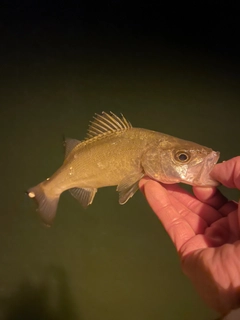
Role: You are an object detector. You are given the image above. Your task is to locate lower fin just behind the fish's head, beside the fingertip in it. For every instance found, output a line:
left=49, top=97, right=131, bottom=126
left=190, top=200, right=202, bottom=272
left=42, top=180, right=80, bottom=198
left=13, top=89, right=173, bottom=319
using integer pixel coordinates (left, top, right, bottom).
left=117, top=172, right=144, bottom=204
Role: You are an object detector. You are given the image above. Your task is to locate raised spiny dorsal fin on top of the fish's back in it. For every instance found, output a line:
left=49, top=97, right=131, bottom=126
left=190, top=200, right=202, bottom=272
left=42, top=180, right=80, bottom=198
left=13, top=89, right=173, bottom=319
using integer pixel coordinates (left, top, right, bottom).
left=86, top=111, right=132, bottom=139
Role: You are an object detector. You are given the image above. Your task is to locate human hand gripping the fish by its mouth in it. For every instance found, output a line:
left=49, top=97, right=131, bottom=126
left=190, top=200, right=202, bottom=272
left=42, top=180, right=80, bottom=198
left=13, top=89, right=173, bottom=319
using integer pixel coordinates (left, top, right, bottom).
left=140, top=156, right=240, bottom=314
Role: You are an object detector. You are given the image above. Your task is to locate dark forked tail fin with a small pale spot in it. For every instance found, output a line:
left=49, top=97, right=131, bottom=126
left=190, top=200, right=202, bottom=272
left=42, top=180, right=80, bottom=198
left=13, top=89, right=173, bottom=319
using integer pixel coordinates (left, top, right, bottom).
left=26, top=183, right=59, bottom=226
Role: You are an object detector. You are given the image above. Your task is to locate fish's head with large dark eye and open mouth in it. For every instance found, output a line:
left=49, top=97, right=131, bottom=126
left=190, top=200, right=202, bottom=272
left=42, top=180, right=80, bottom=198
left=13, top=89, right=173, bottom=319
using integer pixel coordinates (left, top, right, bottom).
left=143, top=139, right=220, bottom=187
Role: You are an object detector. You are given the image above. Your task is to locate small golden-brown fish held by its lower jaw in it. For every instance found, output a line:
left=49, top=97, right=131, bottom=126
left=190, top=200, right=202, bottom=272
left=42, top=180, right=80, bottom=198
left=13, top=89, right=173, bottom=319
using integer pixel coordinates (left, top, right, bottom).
left=26, top=111, right=220, bottom=226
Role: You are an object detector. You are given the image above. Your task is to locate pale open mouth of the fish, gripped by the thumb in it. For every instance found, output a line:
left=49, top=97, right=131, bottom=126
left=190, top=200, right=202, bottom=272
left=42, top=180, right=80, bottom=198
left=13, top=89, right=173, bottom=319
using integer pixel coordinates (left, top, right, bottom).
left=187, top=151, right=220, bottom=187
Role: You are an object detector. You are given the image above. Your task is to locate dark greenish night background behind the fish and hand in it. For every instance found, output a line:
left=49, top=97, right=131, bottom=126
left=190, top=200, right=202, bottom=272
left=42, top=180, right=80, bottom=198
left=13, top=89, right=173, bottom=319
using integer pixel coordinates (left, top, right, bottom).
left=0, top=1, right=240, bottom=320
